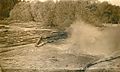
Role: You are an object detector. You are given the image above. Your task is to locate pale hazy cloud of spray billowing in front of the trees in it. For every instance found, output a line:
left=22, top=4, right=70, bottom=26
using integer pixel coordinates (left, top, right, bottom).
left=68, top=21, right=119, bottom=56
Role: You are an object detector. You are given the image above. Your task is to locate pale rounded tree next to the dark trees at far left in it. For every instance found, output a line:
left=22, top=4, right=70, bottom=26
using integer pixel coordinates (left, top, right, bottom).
left=9, top=2, right=32, bottom=21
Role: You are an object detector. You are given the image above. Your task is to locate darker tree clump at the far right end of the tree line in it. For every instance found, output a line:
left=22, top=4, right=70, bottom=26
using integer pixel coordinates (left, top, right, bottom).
left=98, top=2, right=120, bottom=24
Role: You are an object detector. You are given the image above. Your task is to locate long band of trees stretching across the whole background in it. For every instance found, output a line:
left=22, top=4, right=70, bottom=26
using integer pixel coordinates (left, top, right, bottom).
left=0, top=0, right=120, bottom=28
